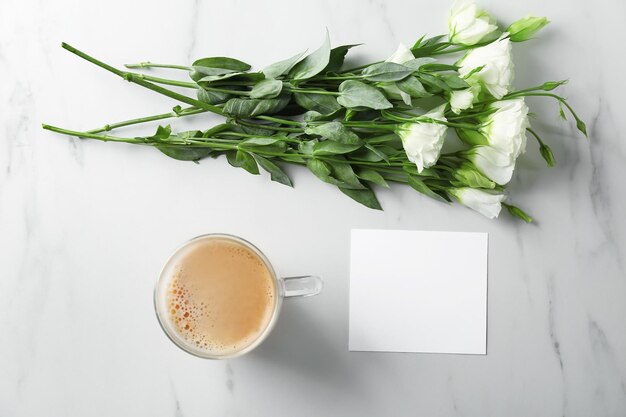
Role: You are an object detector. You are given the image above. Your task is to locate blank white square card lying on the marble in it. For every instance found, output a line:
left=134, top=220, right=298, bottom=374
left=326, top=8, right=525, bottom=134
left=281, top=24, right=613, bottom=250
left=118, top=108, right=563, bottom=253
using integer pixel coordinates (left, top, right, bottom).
left=349, top=230, right=487, bottom=355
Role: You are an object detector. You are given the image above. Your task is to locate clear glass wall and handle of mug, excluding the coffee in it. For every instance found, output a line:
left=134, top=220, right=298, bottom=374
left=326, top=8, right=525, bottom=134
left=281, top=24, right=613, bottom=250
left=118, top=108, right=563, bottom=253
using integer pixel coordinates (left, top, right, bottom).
left=154, top=233, right=323, bottom=359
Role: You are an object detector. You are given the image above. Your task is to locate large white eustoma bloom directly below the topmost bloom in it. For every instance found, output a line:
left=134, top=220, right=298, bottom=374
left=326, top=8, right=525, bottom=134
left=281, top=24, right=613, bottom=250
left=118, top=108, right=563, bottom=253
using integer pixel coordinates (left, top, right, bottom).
left=457, top=34, right=513, bottom=99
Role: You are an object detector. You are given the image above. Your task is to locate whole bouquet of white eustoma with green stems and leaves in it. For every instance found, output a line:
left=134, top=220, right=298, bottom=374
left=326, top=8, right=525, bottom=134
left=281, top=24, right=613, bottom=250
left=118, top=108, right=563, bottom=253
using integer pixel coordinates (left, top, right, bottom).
left=43, top=0, right=586, bottom=222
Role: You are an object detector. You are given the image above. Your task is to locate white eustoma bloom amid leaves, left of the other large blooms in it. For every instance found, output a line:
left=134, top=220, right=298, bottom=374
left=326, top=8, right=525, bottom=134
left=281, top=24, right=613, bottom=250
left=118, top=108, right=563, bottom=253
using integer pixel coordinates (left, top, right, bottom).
left=396, top=104, right=447, bottom=172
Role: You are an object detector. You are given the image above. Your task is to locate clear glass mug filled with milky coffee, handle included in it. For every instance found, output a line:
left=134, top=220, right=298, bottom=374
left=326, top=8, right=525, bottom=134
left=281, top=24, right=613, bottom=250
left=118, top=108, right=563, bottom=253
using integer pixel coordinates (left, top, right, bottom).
left=154, top=234, right=322, bottom=359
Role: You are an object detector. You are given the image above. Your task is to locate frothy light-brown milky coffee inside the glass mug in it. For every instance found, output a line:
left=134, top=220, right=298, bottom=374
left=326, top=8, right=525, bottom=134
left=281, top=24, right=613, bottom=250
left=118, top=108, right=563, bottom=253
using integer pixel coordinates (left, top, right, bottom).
left=164, top=236, right=277, bottom=356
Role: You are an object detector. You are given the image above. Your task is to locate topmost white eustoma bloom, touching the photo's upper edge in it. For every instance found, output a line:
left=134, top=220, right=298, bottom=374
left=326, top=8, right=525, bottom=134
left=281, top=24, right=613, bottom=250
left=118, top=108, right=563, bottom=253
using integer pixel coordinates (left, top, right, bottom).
left=448, top=0, right=498, bottom=45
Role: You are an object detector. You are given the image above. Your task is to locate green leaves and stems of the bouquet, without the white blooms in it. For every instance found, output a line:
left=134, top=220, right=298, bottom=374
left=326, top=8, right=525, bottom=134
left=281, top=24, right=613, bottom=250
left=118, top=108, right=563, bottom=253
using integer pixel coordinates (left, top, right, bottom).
left=45, top=34, right=580, bottom=217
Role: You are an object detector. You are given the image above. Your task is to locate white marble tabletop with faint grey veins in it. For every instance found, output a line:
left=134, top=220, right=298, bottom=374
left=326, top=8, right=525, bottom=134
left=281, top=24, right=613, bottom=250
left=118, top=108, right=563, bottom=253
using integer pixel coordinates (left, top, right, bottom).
left=0, top=0, right=626, bottom=417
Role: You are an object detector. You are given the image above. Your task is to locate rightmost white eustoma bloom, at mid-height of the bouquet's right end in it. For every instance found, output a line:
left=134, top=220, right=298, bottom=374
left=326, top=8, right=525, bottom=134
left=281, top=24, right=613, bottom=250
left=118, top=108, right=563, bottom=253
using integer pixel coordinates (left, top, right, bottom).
left=480, top=98, right=530, bottom=159
